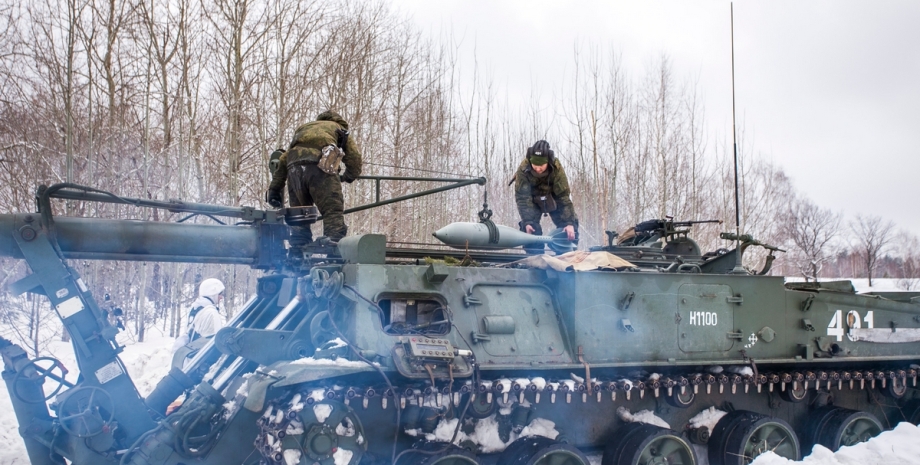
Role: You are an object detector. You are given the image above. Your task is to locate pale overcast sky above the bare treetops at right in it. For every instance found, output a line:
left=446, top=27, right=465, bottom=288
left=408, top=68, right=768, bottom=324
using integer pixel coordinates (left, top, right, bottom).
left=393, top=0, right=920, bottom=235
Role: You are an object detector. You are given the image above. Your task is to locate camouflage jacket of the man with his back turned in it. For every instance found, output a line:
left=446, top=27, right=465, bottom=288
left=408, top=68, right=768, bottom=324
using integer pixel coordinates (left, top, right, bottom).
left=269, top=111, right=362, bottom=190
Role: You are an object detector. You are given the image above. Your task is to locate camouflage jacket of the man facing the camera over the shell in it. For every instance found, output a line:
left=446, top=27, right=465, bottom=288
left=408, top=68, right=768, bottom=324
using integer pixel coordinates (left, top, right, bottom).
left=514, top=159, right=578, bottom=228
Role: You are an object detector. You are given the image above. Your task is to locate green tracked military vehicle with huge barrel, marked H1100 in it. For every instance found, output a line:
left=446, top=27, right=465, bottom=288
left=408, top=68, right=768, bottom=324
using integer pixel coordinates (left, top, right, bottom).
left=0, top=179, right=920, bottom=465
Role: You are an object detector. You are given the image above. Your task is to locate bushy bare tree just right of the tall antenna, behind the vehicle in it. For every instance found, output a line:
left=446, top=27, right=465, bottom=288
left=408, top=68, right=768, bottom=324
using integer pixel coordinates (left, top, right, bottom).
left=782, top=197, right=840, bottom=281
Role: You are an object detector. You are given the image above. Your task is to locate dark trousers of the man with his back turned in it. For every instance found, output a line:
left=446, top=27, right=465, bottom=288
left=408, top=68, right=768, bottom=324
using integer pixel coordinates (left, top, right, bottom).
left=287, top=163, right=348, bottom=246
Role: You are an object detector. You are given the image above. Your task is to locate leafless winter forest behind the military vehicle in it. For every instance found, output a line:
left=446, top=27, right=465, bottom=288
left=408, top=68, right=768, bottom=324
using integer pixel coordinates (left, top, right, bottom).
left=0, top=0, right=920, bottom=353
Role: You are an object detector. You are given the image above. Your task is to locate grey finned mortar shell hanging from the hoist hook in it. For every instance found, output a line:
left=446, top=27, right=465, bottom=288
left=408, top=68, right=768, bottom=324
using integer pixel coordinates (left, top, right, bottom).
left=433, top=222, right=575, bottom=253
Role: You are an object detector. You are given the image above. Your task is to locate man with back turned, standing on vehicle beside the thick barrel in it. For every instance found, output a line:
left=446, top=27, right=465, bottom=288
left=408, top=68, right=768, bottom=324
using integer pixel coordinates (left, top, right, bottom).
left=266, top=111, right=361, bottom=246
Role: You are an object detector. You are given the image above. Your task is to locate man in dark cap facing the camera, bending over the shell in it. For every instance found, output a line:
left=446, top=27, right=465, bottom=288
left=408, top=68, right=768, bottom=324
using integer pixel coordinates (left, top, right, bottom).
left=514, top=140, right=578, bottom=253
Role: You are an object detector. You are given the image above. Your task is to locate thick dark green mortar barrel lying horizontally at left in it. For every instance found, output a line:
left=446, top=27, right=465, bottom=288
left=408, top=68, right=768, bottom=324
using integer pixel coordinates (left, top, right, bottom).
left=0, top=213, right=287, bottom=267
